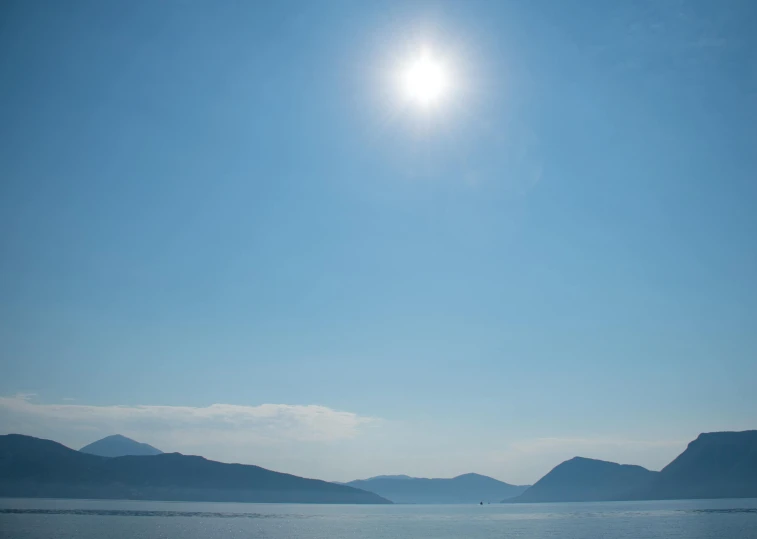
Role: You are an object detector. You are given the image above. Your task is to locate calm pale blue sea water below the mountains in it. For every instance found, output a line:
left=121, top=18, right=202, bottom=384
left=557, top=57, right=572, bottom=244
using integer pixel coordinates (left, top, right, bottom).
left=0, top=499, right=757, bottom=539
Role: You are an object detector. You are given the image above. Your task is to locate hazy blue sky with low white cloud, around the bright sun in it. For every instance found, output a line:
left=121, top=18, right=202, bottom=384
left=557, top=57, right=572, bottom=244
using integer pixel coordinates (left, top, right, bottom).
left=0, top=0, right=757, bottom=483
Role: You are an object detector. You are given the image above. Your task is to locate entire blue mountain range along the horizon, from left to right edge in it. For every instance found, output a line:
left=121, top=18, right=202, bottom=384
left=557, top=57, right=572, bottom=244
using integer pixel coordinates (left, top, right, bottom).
left=0, top=430, right=757, bottom=503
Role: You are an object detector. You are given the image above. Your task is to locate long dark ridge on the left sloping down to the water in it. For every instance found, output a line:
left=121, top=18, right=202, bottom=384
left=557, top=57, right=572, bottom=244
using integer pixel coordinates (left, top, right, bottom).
left=0, top=434, right=391, bottom=503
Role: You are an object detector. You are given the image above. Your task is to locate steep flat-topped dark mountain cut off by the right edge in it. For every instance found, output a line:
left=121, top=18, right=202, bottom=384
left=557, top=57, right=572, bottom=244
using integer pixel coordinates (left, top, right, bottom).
left=635, top=430, right=757, bottom=499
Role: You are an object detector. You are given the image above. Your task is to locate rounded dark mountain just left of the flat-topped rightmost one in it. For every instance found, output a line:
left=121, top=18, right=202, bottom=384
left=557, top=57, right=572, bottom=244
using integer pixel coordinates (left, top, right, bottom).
left=504, top=457, right=659, bottom=503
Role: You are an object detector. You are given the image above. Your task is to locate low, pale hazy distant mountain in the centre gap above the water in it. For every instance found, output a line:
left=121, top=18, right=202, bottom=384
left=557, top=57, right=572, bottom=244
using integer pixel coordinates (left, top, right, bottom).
left=346, top=473, right=528, bottom=503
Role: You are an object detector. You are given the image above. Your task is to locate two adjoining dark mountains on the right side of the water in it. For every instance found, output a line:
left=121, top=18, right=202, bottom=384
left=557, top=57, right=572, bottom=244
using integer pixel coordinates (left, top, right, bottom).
left=503, top=430, right=757, bottom=503
